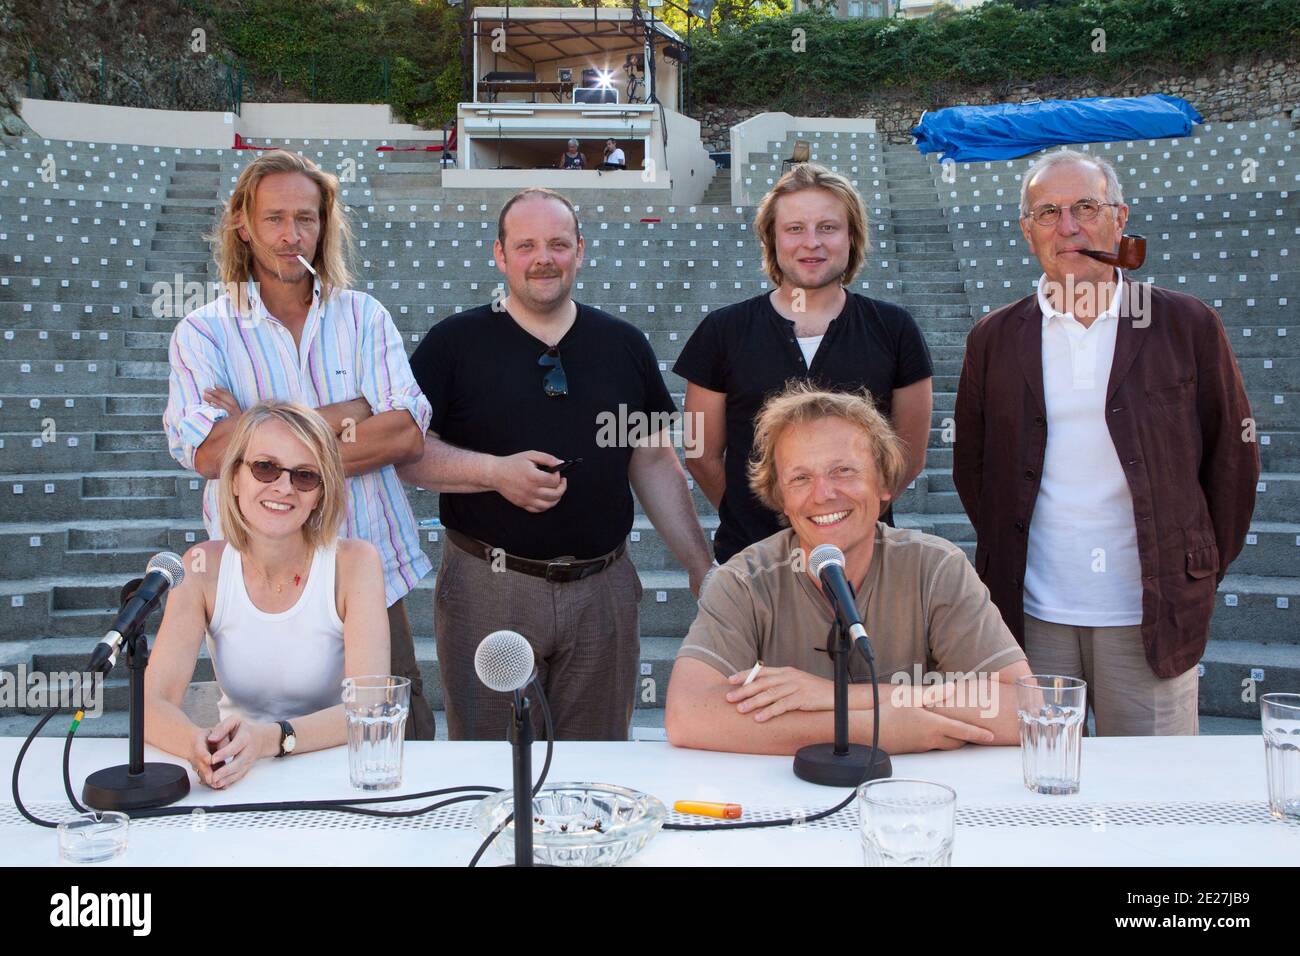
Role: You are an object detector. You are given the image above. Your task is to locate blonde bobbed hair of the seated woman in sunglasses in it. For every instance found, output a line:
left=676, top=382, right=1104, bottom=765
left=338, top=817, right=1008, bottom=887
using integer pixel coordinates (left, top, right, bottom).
left=217, top=401, right=347, bottom=551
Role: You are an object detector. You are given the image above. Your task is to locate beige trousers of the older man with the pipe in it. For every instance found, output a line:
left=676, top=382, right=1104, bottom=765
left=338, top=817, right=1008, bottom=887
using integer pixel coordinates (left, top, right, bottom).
left=1024, top=614, right=1200, bottom=737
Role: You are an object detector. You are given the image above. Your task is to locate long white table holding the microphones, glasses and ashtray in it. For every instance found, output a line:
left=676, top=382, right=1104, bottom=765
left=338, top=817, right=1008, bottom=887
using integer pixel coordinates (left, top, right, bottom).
left=0, top=736, right=1300, bottom=866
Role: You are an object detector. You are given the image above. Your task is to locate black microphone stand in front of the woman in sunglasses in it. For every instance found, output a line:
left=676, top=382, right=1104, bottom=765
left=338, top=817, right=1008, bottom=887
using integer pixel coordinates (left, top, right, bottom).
left=82, top=585, right=190, bottom=810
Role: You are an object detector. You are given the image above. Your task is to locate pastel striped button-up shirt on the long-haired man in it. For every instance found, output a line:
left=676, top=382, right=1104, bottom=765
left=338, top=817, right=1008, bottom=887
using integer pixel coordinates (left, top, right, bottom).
left=163, top=281, right=433, bottom=605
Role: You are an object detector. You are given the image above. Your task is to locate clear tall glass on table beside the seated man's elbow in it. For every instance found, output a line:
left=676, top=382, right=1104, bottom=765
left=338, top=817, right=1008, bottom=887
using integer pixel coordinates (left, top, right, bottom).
left=1015, top=674, right=1088, bottom=793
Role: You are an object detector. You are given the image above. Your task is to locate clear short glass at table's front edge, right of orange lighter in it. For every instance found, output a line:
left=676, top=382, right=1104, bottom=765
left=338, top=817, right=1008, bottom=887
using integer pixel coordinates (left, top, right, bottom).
left=858, top=779, right=957, bottom=866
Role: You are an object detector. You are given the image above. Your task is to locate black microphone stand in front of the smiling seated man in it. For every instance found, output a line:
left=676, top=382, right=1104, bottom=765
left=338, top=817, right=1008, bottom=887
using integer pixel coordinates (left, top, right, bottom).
left=794, top=584, right=893, bottom=787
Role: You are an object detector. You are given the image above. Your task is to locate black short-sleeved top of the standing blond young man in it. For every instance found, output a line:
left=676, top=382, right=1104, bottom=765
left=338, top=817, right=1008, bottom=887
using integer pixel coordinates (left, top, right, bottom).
left=672, top=293, right=933, bottom=563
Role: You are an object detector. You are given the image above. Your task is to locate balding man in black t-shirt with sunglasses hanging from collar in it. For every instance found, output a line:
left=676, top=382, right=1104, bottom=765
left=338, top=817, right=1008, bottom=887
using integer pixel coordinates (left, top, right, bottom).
left=398, top=189, right=710, bottom=740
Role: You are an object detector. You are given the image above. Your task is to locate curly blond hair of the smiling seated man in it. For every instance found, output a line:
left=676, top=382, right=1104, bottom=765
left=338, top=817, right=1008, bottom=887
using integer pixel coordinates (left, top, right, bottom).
left=749, top=380, right=907, bottom=525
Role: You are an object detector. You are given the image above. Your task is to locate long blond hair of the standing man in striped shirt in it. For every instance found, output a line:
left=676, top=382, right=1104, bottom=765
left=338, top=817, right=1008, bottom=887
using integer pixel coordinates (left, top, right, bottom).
left=204, top=150, right=352, bottom=306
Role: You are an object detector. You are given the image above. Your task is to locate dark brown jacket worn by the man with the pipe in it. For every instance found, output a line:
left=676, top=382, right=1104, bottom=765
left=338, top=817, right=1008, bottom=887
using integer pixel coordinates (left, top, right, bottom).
left=953, top=280, right=1260, bottom=678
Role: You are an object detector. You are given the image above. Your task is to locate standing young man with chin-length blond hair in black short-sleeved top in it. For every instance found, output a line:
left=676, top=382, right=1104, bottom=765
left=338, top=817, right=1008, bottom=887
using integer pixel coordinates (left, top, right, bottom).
left=673, top=163, right=933, bottom=564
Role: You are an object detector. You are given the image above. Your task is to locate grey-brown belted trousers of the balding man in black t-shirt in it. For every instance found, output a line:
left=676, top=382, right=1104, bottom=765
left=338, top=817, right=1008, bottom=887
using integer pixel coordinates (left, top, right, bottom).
left=433, top=541, right=641, bottom=740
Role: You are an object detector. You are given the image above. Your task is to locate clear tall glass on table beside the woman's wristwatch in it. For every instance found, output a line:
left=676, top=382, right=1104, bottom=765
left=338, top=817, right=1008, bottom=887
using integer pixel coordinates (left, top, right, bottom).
left=343, top=674, right=411, bottom=790
